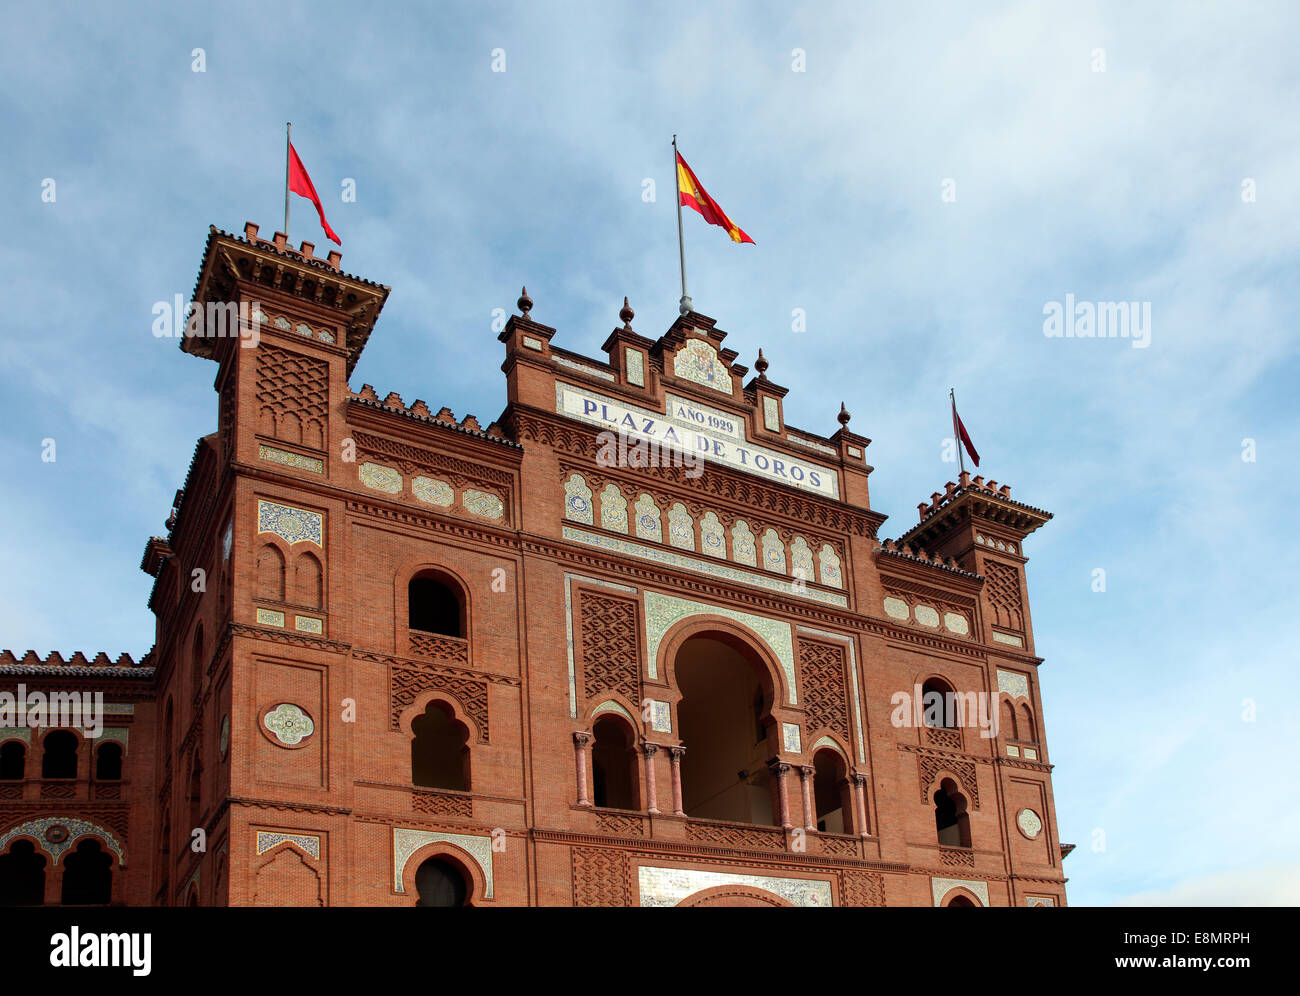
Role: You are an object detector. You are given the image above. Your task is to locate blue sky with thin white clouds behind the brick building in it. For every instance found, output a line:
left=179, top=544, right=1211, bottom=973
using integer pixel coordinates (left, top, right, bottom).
left=0, top=3, right=1300, bottom=905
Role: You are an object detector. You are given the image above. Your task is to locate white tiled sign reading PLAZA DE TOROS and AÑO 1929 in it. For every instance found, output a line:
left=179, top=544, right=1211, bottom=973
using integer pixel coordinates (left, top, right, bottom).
left=555, top=384, right=840, bottom=498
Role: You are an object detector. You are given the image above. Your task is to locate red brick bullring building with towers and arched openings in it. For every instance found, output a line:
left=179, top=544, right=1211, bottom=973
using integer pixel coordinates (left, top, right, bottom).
left=0, top=225, right=1069, bottom=906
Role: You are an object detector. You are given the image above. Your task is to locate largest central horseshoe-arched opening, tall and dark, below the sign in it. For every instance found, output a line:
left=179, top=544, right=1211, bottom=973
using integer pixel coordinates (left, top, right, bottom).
left=672, top=633, right=776, bottom=827
